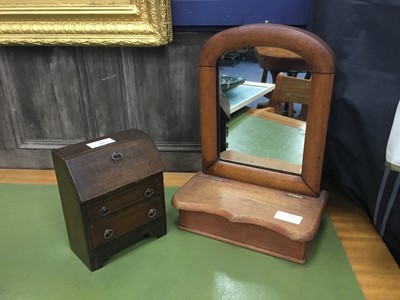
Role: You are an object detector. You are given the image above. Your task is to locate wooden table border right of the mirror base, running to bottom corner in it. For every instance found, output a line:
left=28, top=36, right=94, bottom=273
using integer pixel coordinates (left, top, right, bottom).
left=325, top=180, right=400, bottom=300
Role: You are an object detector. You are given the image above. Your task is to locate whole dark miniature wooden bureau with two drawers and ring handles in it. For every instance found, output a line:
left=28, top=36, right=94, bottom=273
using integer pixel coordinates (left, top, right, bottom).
left=52, top=129, right=166, bottom=271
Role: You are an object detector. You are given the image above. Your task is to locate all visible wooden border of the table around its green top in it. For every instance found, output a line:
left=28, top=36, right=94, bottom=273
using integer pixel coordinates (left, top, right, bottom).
left=0, top=169, right=400, bottom=300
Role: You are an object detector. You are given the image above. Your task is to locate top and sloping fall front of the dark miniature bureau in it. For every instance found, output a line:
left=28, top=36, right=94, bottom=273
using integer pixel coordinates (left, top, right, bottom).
left=54, top=130, right=164, bottom=202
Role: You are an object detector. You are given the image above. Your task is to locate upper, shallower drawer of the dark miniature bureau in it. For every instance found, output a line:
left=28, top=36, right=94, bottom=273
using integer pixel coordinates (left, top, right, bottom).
left=88, top=179, right=164, bottom=221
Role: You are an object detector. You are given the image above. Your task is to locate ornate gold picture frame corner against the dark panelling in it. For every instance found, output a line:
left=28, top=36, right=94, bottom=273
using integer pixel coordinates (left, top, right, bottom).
left=0, top=0, right=172, bottom=47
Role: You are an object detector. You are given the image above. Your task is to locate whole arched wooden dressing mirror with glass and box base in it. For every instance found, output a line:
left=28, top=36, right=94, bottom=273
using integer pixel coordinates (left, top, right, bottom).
left=172, top=24, right=334, bottom=263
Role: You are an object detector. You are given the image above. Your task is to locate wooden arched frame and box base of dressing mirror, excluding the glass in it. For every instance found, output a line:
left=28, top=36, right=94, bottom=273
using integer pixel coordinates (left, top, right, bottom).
left=172, top=24, right=334, bottom=263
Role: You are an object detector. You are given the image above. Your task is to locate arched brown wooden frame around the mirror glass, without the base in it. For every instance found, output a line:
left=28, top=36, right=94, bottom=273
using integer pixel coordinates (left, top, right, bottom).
left=199, top=24, right=334, bottom=197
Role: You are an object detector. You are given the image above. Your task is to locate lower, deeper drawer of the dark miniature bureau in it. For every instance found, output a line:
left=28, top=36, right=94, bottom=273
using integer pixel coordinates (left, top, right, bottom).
left=91, top=197, right=164, bottom=247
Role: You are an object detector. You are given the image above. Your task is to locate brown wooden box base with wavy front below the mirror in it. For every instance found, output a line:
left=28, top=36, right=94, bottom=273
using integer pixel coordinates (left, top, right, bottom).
left=172, top=172, right=327, bottom=263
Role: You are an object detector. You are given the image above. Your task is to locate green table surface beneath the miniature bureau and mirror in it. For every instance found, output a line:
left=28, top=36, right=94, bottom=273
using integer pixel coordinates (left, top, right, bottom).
left=0, top=184, right=363, bottom=300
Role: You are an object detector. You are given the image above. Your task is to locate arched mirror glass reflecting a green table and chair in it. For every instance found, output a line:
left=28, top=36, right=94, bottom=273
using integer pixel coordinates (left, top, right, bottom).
left=217, top=47, right=311, bottom=175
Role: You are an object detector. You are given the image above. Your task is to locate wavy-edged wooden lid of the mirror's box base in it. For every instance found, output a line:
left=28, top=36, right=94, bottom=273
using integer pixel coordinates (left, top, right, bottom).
left=172, top=172, right=327, bottom=242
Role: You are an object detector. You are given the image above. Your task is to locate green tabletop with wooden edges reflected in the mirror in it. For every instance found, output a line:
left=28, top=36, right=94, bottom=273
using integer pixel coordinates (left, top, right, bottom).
left=221, top=108, right=306, bottom=173
